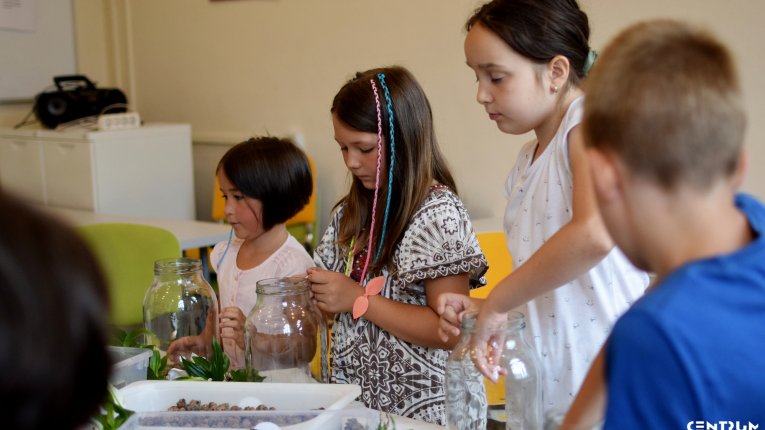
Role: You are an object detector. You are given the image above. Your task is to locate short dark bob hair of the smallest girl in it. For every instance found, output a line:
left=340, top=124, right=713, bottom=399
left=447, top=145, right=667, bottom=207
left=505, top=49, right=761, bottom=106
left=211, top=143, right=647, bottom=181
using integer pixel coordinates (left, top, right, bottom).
left=216, top=136, right=313, bottom=230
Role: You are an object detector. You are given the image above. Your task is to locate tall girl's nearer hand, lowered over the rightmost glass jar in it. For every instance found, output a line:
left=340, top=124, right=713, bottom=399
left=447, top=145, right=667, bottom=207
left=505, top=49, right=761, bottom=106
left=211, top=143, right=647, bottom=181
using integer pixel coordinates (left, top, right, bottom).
left=471, top=306, right=507, bottom=382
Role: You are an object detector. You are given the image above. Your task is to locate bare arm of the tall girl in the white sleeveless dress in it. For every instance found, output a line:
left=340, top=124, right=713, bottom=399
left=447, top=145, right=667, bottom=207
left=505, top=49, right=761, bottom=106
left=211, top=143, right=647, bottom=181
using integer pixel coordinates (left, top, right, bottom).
left=474, top=127, right=613, bottom=378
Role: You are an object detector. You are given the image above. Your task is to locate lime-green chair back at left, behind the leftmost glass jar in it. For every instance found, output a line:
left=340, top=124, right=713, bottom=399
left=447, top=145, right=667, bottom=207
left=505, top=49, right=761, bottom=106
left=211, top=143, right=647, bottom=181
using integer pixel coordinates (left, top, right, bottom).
left=76, top=223, right=181, bottom=329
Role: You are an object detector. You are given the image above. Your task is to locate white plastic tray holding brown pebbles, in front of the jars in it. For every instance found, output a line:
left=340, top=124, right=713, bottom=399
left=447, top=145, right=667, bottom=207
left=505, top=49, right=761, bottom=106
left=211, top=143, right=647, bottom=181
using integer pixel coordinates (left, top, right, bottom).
left=119, top=381, right=361, bottom=412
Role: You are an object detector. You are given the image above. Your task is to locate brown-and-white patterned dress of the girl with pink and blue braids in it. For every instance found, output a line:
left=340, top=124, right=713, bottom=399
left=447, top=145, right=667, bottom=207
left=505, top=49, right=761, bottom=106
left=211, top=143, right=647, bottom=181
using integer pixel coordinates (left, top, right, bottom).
left=314, top=187, right=487, bottom=424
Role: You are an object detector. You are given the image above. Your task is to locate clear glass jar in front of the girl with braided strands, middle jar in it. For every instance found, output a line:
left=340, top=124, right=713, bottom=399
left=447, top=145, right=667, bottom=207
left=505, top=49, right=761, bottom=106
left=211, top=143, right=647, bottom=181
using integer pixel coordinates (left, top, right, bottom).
left=244, top=277, right=327, bottom=382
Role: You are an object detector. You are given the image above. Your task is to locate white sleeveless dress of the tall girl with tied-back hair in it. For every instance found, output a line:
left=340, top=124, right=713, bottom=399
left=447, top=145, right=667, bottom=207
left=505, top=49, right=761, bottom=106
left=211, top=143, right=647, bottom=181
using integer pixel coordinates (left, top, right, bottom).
left=504, top=97, right=648, bottom=411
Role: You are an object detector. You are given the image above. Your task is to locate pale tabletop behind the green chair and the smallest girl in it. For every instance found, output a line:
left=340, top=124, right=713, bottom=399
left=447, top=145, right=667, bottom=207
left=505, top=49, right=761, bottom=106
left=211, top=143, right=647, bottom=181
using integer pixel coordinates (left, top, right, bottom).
left=42, top=206, right=231, bottom=250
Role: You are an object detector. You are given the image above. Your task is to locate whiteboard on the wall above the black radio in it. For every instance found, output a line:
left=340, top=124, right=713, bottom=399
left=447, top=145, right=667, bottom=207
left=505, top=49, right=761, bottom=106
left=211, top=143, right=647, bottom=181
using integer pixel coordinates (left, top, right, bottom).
left=0, top=0, right=77, bottom=103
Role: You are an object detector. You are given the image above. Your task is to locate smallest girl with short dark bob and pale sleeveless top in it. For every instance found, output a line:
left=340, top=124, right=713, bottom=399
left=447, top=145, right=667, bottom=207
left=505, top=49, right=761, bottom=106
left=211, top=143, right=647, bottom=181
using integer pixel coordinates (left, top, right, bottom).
left=210, top=137, right=314, bottom=368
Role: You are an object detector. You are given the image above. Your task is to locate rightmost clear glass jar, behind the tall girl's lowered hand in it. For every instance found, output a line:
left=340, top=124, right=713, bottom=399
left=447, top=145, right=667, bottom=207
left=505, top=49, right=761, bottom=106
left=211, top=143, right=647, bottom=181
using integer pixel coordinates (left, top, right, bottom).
left=446, top=312, right=543, bottom=430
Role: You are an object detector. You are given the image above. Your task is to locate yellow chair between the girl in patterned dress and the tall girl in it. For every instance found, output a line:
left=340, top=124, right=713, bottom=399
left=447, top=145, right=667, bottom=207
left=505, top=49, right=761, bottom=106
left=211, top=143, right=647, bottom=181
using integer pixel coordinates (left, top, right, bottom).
left=470, top=231, right=513, bottom=405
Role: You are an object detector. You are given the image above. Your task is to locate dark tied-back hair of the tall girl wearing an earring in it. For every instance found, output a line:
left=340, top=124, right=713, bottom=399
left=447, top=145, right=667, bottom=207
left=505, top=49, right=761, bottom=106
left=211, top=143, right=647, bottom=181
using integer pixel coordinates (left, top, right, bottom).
left=465, top=0, right=590, bottom=86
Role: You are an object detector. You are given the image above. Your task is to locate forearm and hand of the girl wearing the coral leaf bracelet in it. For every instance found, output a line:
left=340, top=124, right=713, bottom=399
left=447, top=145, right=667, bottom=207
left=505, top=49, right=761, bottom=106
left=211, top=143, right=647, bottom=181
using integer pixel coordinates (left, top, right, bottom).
left=309, top=269, right=469, bottom=349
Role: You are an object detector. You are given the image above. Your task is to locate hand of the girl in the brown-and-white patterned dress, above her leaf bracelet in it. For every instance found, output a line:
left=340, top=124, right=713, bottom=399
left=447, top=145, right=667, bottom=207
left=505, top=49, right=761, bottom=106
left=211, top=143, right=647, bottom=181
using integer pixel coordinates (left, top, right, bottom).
left=307, top=267, right=364, bottom=313
